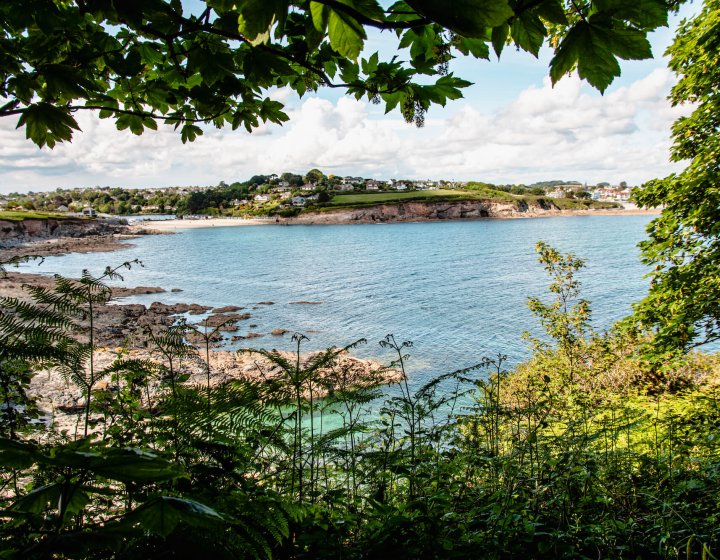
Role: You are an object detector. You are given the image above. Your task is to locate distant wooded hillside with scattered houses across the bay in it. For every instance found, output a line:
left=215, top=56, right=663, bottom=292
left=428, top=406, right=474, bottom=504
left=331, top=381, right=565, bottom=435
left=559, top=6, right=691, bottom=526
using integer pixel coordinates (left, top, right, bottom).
left=0, top=169, right=634, bottom=216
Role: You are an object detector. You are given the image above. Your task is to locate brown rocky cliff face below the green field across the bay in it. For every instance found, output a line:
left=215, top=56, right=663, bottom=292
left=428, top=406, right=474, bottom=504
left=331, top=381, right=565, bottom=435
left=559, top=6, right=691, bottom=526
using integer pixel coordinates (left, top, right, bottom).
left=282, top=199, right=572, bottom=224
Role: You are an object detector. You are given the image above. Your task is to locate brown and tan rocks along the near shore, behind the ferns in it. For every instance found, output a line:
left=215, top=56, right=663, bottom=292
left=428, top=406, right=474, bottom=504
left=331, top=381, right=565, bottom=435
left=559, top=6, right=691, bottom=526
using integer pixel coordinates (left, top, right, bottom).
left=0, top=247, right=401, bottom=433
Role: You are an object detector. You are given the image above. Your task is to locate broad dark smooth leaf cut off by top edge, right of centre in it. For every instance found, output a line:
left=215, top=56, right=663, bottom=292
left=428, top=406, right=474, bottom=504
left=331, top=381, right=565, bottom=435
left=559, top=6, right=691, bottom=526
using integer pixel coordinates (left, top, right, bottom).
left=407, top=0, right=515, bottom=38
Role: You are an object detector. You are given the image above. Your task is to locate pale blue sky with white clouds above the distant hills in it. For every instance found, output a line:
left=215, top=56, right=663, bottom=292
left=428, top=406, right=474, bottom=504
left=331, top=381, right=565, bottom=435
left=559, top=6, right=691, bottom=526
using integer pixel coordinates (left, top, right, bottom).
left=0, top=3, right=699, bottom=194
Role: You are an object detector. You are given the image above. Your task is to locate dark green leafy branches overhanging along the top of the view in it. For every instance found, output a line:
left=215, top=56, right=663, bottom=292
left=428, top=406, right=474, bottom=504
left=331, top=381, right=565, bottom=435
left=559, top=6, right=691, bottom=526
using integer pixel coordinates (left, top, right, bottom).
left=0, top=0, right=683, bottom=148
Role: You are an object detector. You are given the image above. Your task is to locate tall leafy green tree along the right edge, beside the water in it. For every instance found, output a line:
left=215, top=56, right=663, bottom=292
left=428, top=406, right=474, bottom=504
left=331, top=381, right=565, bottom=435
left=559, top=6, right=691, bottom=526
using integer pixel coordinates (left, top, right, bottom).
left=635, top=0, right=720, bottom=351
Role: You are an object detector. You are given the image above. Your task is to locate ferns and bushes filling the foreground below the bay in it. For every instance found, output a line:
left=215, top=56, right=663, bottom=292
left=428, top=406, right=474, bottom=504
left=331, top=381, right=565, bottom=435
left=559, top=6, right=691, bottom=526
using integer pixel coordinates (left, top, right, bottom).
left=0, top=243, right=720, bottom=560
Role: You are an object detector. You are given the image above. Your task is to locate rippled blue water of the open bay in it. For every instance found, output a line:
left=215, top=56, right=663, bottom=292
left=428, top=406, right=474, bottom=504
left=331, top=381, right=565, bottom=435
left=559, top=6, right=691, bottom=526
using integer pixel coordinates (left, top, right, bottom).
left=21, top=216, right=651, bottom=388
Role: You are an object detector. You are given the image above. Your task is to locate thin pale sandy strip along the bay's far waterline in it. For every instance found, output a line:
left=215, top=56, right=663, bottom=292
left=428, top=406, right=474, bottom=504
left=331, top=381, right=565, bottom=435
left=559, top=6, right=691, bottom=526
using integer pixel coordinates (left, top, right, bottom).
left=128, top=208, right=660, bottom=233
